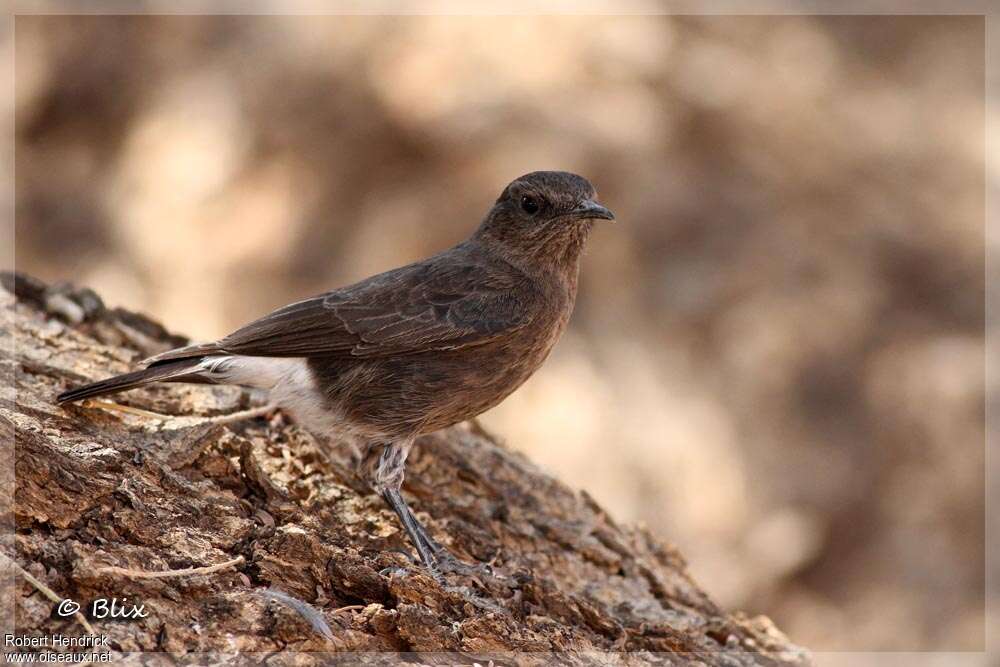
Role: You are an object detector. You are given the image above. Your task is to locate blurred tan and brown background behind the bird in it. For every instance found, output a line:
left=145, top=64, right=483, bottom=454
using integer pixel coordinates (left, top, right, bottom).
left=15, top=16, right=985, bottom=651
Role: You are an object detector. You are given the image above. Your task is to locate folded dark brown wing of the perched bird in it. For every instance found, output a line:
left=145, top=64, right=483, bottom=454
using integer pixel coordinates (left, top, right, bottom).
left=204, top=258, right=533, bottom=357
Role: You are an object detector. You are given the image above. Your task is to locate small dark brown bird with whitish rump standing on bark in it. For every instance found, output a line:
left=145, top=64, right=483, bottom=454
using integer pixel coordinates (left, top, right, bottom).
left=56, top=171, right=615, bottom=574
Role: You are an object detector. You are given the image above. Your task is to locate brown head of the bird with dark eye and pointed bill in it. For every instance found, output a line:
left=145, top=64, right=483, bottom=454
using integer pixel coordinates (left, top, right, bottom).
left=476, top=171, right=615, bottom=262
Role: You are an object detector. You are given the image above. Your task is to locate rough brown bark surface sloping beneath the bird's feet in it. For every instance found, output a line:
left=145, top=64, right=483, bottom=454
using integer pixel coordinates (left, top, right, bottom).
left=0, top=276, right=808, bottom=665
